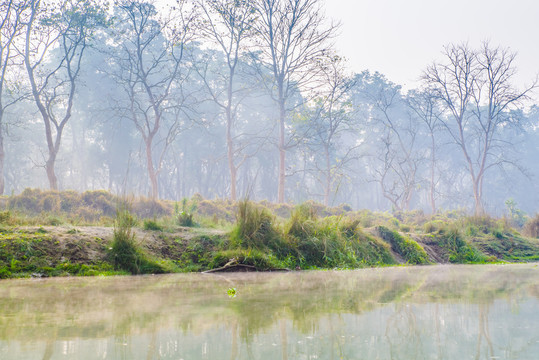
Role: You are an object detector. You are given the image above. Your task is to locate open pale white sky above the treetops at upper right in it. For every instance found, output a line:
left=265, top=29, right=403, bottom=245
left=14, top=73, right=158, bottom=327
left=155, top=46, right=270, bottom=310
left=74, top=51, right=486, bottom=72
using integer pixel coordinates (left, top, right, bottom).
left=325, top=0, right=539, bottom=88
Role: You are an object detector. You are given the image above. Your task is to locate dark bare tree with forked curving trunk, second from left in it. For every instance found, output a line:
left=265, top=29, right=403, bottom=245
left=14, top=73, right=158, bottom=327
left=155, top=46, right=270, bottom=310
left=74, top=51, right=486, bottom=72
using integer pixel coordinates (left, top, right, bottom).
left=22, top=0, right=105, bottom=190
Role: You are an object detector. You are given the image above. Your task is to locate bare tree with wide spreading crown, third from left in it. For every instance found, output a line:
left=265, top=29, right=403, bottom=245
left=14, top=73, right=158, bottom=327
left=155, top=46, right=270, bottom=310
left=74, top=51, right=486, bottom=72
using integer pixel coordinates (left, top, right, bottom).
left=110, top=0, right=194, bottom=199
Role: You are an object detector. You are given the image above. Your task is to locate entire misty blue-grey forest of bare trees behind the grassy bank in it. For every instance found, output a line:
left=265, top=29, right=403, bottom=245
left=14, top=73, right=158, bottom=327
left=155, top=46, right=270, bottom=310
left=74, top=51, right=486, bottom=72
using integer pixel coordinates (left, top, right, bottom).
left=0, top=0, right=539, bottom=217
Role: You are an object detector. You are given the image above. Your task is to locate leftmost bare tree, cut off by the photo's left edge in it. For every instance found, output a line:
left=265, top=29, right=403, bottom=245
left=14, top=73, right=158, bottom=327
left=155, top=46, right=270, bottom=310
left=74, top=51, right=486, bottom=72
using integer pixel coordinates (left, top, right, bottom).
left=0, top=0, right=29, bottom=195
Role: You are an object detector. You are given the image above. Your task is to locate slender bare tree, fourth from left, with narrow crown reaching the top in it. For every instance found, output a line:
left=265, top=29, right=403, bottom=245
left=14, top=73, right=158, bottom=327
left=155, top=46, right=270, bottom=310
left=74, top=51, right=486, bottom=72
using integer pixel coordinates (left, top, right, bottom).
left=195, top=0, right=255, bottom=201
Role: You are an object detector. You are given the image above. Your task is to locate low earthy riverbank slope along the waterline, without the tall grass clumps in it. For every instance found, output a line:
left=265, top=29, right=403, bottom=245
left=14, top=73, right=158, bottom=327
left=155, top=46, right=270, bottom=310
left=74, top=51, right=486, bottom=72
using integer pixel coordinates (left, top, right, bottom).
left=0, top=219, right=539, bottom=278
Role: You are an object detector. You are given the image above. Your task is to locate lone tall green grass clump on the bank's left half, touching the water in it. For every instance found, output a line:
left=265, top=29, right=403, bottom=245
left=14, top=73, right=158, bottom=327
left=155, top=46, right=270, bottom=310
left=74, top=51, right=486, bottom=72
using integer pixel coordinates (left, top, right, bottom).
left=110, top=202, right=166, bottom=275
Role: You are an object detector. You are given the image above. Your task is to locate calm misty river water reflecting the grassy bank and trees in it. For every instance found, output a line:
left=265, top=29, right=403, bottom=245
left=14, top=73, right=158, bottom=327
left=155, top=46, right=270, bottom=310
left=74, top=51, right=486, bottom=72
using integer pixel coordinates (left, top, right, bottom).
left=0, top=264, right=539, bottom=360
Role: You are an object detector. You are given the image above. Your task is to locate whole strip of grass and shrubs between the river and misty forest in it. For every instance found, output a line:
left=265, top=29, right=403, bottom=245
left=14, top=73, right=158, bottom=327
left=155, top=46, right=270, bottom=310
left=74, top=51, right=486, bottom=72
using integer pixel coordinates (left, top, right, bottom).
left=0, top=189, right=539, bottom=278
